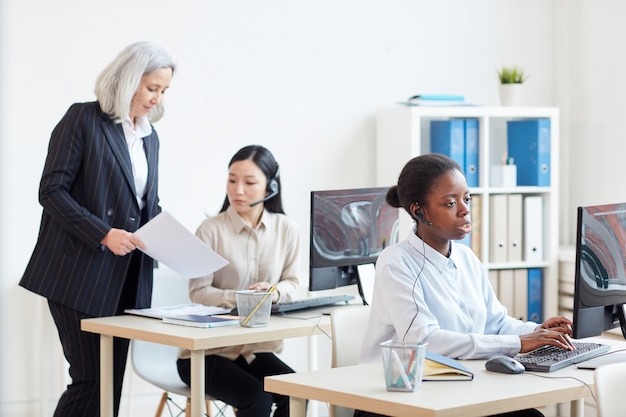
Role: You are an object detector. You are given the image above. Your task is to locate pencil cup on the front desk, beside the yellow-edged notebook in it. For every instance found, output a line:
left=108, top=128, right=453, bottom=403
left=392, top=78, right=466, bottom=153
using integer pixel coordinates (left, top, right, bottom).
left=380, top=340, right=428, bottom=391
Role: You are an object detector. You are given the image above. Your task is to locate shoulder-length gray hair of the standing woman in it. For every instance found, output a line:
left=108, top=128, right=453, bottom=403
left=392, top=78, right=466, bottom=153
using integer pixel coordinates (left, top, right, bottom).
left=95, top=42, right=176, bottom=122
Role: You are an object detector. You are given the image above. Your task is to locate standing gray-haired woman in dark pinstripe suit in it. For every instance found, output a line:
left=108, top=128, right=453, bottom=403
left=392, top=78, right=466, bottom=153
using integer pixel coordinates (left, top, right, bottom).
left=20, top=42, right=175, bottom=417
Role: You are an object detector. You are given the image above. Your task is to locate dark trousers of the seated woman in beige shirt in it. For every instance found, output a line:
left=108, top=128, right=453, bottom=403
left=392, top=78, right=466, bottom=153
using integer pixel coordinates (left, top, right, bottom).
left=178, top=353, right=294, bottom=417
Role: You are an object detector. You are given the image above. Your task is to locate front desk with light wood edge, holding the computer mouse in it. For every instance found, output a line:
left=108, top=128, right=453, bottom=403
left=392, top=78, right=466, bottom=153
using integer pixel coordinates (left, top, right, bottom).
left=265, top=339, right=626, bottom=417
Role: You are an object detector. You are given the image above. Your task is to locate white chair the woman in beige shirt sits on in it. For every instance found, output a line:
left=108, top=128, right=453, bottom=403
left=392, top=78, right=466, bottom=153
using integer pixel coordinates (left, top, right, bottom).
left=130, top=265, right=233, bottom=417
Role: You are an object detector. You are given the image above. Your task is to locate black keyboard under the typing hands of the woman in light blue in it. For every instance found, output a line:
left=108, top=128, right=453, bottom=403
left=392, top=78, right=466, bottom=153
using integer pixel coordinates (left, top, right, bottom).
left=515, top=342, right=610, bottom=372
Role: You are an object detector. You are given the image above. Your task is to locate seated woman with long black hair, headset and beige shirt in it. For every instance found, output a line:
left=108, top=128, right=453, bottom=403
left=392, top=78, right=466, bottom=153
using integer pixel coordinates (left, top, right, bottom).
left=178, top=145, right=299, bottom=417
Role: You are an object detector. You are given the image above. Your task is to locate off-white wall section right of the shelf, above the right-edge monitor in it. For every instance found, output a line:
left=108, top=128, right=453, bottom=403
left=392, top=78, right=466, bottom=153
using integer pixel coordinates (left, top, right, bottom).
left=555, top=0, right=626, bottom=243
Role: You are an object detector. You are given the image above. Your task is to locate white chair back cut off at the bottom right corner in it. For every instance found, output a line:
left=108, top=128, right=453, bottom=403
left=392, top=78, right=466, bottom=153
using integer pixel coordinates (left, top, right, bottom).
left=593, top=362, right=626, bottom=417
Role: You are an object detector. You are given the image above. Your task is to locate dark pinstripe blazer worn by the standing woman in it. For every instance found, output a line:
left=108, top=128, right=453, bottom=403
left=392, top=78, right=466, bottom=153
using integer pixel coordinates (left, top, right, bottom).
left=20, top=102, right=160, bottom=317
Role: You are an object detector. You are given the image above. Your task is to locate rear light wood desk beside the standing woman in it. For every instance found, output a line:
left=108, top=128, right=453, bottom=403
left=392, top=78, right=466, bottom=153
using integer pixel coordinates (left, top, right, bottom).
left=81, top=310, right=330, bottom=417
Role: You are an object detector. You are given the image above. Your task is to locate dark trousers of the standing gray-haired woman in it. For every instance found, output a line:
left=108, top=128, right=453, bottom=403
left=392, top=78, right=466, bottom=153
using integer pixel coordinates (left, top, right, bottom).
left=48, top=301, right=129, bottom=417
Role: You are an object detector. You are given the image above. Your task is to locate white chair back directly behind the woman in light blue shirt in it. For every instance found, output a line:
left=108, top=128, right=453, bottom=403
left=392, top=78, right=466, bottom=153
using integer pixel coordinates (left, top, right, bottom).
left=330, top=306, right=370, bottom=417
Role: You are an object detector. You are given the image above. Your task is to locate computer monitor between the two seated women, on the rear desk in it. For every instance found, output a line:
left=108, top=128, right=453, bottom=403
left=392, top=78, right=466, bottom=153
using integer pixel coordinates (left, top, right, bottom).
left=309, top=187, right=399, bottom=303
